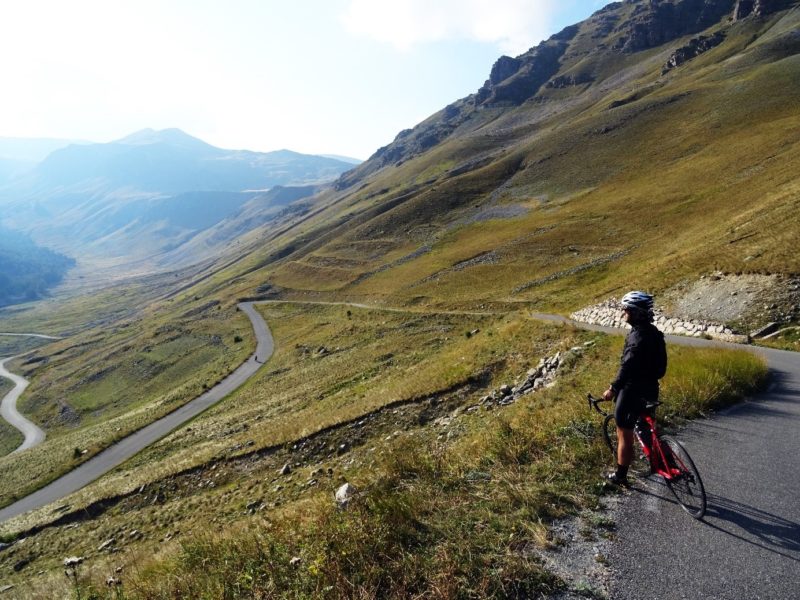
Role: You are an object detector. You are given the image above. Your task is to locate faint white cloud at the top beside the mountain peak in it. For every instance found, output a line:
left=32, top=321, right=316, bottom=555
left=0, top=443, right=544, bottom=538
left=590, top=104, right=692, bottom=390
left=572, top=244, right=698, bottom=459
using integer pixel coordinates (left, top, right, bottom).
left=342, top=0, right=557, bottom=55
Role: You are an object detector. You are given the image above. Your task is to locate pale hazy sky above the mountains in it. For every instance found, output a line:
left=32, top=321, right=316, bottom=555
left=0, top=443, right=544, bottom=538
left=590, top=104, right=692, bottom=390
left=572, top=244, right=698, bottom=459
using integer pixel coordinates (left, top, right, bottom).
left=0, top=0, right=606, bottom=158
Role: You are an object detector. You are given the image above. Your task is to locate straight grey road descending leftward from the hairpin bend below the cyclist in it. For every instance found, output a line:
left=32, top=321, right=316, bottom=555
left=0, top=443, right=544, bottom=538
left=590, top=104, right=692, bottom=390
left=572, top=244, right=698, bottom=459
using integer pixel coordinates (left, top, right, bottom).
left=0, top=302, right=274, bottom=522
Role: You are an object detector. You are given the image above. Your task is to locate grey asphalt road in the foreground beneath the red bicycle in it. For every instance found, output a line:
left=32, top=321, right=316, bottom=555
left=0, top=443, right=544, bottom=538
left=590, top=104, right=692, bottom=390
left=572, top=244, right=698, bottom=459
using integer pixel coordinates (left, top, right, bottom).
left=537, top=315, right=800, bottom=600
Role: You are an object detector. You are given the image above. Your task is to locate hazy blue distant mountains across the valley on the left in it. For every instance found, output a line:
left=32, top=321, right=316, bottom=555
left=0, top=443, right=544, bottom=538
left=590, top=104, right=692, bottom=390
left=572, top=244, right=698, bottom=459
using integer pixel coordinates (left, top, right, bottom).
left=0, top=128, right=353, bottom=278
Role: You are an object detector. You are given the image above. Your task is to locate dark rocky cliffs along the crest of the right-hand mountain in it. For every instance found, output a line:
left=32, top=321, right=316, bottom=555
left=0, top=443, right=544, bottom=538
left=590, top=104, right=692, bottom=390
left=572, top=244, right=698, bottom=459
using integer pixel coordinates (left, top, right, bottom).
left=337, top=0, right=797, bottom=189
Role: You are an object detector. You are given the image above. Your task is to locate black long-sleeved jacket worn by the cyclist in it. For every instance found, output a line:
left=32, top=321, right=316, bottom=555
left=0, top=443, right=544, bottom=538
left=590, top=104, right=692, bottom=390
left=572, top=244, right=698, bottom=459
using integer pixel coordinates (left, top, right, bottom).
left=611, top=323, right=667, bottom=397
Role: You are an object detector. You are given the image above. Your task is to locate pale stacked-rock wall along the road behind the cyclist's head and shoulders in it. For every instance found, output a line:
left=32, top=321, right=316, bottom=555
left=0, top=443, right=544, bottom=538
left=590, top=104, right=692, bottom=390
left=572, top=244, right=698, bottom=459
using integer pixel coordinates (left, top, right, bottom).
left=570, top=298, right=747, bottom=343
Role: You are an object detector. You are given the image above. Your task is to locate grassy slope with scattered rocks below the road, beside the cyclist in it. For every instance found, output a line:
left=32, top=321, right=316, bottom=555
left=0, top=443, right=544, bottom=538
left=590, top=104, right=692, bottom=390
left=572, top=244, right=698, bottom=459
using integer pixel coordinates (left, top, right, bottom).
left=0, top=305, right=764, bottom=597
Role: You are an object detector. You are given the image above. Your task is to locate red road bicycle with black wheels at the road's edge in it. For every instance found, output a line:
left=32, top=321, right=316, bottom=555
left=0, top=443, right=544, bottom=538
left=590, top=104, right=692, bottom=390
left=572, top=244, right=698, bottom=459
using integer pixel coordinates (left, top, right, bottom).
left=587, top=394, right=706, bottom=519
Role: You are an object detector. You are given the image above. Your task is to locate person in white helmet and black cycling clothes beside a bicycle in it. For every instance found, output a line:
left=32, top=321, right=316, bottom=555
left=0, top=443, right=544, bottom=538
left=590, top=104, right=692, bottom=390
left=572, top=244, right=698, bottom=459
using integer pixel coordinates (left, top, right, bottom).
left=603, top=291, right=667, bottom=485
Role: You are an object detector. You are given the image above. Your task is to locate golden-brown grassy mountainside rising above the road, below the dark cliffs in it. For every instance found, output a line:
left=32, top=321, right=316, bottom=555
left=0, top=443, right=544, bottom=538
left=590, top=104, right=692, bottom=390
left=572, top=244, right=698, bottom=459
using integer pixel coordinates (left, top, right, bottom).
left=195, top=10, right=800, bottom=311
